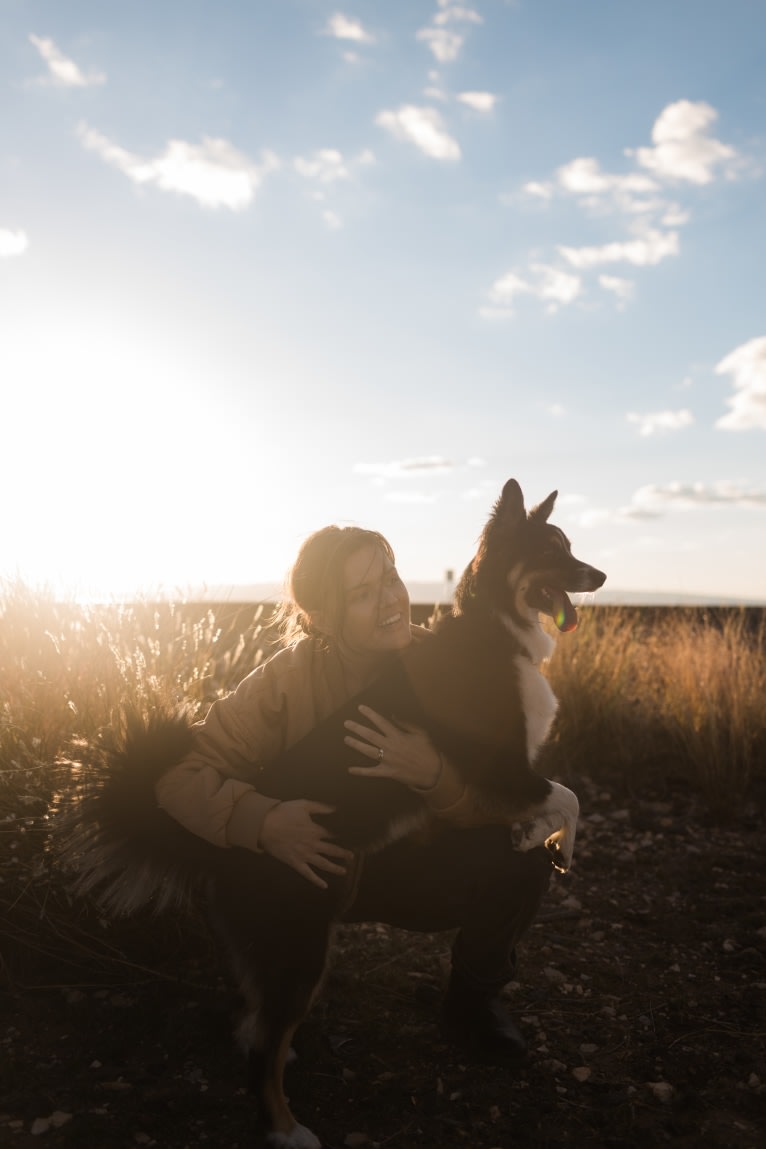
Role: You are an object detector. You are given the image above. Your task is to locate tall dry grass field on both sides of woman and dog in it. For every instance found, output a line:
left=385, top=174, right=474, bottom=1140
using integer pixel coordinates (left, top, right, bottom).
left=0, top=581, right=766, bottom=983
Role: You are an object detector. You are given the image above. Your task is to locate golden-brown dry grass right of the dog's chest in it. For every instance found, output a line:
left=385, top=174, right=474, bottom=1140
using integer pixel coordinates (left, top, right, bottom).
left=549, top=608, right=766, bottom=816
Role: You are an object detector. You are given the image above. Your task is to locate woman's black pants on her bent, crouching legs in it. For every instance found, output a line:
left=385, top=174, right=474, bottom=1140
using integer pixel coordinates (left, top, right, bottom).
left=343, top=826, right=552, bottom=993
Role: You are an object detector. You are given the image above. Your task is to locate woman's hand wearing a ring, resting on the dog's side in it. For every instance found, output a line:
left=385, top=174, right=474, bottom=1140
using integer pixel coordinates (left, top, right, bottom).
left=343, top=707, right=442, bottom=791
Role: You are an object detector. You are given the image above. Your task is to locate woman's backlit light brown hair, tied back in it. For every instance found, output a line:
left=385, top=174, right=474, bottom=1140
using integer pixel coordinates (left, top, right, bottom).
left=276, top=526, right=395, bottom=646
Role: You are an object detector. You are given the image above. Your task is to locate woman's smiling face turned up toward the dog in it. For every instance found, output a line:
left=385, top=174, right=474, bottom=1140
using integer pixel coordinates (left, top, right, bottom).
left=340, top=543, right=411, bottom=654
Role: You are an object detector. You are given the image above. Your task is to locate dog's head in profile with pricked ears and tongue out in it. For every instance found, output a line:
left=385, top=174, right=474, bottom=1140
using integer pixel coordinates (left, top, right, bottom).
left=455, top=479, right=606, bottom=631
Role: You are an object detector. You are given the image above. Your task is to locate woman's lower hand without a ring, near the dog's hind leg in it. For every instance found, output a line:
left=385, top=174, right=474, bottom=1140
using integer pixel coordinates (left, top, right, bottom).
left=258, top=799, right=354, bottom=889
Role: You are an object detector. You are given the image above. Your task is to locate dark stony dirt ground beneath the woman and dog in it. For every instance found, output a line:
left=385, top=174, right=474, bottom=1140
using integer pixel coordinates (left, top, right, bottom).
left=0, top=786, right=766, bottom=1149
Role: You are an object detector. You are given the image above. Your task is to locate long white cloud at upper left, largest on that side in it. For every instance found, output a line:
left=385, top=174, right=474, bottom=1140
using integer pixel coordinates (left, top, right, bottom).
left=77, top=124, right=278, bottom=211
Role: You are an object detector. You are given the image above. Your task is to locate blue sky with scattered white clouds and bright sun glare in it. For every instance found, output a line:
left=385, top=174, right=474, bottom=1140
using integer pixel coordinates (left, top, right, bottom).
left=0, top=0, right=766, bottom=602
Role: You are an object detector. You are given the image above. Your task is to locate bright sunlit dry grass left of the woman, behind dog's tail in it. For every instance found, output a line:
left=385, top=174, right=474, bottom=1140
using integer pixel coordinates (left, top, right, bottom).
left=0, top=581, right=275, bottom=818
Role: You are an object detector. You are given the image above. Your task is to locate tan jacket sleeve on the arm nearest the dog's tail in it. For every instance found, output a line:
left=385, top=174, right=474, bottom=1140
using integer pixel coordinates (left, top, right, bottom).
left=156, top=650, right=292, bottom=851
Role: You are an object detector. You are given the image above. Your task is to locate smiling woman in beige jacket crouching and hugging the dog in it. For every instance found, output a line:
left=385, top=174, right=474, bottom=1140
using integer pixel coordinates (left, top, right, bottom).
left=157, top=526, right=551, bottom=1058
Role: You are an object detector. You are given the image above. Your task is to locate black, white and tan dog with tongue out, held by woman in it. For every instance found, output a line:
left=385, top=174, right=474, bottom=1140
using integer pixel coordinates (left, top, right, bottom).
left=62, top=479, right=606, bottom=1149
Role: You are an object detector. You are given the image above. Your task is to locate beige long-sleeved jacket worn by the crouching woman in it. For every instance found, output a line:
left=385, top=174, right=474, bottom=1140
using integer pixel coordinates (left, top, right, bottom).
left=156, top=626, right=487, bottom=851
